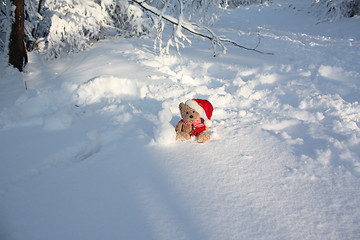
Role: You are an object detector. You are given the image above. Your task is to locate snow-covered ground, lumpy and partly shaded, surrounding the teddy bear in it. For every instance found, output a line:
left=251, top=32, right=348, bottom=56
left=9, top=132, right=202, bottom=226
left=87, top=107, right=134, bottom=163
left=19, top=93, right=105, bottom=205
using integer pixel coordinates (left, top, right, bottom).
left=0, top=1, right=360, bottom=240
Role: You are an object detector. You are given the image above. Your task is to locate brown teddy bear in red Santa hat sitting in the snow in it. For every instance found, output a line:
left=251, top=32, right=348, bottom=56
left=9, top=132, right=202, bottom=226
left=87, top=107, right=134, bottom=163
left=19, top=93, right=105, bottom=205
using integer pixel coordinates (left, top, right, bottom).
left=175, top=99, right=214, bottom=143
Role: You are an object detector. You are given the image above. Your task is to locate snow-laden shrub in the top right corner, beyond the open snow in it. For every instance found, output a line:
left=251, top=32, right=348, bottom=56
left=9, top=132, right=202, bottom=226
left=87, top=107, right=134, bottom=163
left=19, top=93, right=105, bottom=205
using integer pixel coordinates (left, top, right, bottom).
left=311, top=0, right=360, bottom=21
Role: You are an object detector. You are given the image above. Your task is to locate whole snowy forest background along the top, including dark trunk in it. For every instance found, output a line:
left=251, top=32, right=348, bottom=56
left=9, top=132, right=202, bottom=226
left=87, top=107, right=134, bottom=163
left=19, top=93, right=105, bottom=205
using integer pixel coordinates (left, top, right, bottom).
left=0, top=0, right=360, bottom=71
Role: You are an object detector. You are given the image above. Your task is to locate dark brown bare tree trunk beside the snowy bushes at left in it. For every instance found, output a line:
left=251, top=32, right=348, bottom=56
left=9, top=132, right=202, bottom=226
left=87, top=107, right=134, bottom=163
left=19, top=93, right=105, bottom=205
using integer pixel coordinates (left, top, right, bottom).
left=9, top=0, right=28, bottom=71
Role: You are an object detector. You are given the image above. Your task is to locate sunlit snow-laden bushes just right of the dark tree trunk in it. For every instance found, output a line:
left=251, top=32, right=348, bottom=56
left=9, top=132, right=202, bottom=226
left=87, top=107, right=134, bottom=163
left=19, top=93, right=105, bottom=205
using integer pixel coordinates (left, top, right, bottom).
left=20, top=0, right=149, bottom=58
